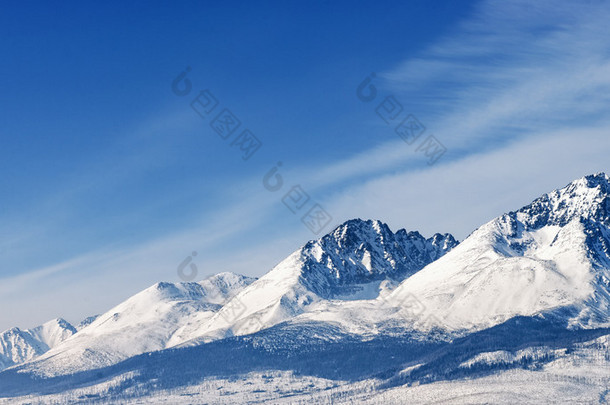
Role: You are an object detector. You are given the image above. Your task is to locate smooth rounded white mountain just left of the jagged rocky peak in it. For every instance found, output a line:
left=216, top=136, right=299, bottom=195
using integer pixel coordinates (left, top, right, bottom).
left=17, top=273, right=254, bottom=375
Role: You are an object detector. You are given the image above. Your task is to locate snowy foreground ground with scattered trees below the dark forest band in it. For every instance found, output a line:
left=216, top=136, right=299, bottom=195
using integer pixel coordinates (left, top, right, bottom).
left=0, top=335, right=610, bottom=405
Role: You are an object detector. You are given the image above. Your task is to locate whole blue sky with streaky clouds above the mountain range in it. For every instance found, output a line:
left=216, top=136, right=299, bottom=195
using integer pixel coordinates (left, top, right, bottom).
left=0, top=1, right=610, bottom=330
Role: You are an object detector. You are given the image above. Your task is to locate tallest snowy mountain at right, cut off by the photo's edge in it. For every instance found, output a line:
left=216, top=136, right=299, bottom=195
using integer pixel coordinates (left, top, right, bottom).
left=387, top=173, right=610, bottom=330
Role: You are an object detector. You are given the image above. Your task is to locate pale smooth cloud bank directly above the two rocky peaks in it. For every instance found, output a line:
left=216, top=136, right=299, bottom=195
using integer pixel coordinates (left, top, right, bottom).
left=318, top=126, right=610, bottom=238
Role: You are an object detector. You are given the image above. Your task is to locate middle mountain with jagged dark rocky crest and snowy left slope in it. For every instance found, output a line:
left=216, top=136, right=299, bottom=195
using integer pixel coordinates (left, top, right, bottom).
left=193, top=219, right=458, bottom=341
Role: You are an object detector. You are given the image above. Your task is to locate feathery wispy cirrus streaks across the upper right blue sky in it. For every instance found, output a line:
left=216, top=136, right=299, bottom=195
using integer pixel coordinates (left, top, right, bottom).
left=296, top=1, right=610, bottom=196
